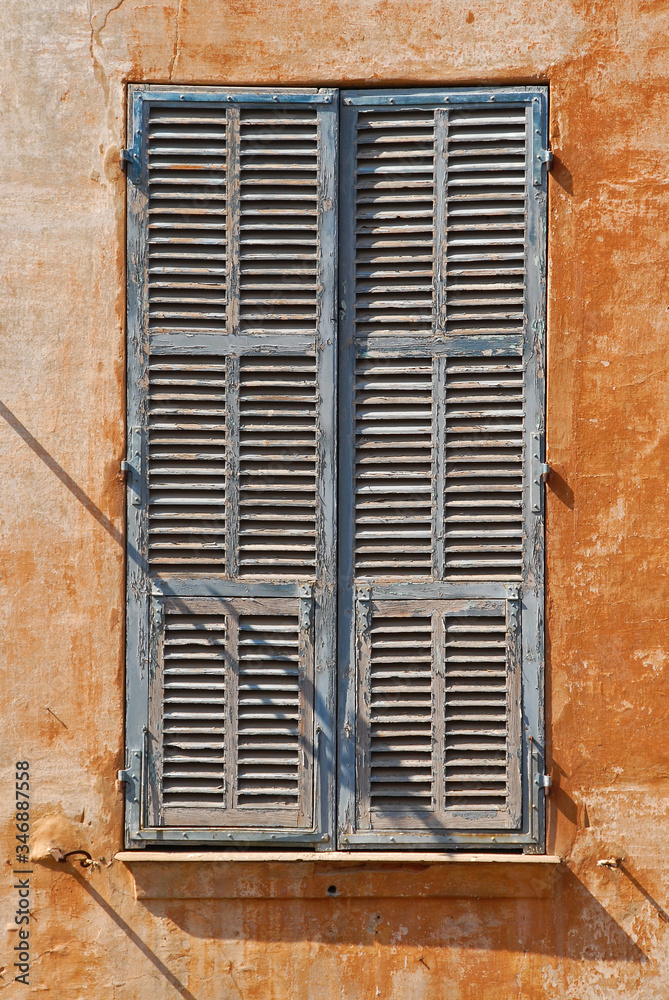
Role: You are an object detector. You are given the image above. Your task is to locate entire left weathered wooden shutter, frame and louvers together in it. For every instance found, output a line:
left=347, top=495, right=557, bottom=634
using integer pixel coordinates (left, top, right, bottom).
left=126, top=87, right=337, bottom=845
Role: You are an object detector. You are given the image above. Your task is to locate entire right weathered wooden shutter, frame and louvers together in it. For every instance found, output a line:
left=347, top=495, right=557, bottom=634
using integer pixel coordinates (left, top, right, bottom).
left=339, top=88, right=546, bottom=850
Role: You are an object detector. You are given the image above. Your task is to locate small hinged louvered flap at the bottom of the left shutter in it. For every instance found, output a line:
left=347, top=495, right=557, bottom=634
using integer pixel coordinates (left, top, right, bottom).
left=150, top=597, right=314, bottom=828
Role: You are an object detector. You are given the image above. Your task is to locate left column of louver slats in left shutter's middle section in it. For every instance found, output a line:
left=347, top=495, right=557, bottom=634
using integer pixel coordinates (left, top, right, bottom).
left=148, top=355, right=226, bottom=576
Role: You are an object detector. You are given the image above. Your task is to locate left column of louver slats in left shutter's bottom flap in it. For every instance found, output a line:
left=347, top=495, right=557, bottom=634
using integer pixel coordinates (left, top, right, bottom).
left=162, top=613, right=229, bottom=809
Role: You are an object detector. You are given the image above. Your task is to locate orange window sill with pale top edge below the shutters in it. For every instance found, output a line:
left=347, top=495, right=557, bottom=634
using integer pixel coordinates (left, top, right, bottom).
left=116, top=851, right=562, bottom=899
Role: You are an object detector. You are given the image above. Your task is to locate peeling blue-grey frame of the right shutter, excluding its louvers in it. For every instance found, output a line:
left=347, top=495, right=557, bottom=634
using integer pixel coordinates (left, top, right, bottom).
left=339, top=87, right=547, bottom=853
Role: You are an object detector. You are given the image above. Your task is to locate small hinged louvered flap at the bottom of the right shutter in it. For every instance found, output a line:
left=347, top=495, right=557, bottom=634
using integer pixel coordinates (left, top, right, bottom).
left=357, top=600, right=521, bottom=832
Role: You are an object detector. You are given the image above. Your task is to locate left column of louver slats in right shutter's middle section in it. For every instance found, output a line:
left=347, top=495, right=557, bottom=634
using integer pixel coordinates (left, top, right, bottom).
left=355, top=358, right=433, bottom=577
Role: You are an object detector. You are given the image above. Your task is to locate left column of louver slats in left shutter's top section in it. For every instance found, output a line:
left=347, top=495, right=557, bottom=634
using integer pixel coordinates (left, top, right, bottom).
left=147, top=106, right=227, bottom=333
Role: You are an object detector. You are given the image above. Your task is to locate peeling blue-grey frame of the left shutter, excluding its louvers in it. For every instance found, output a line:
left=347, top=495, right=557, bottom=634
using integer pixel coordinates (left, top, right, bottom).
left=126, top=85, right=337, bottom=849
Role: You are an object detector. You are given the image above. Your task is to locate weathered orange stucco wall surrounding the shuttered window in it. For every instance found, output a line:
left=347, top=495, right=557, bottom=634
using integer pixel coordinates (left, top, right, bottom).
left=0, top=0, right=669, bottom=1000
